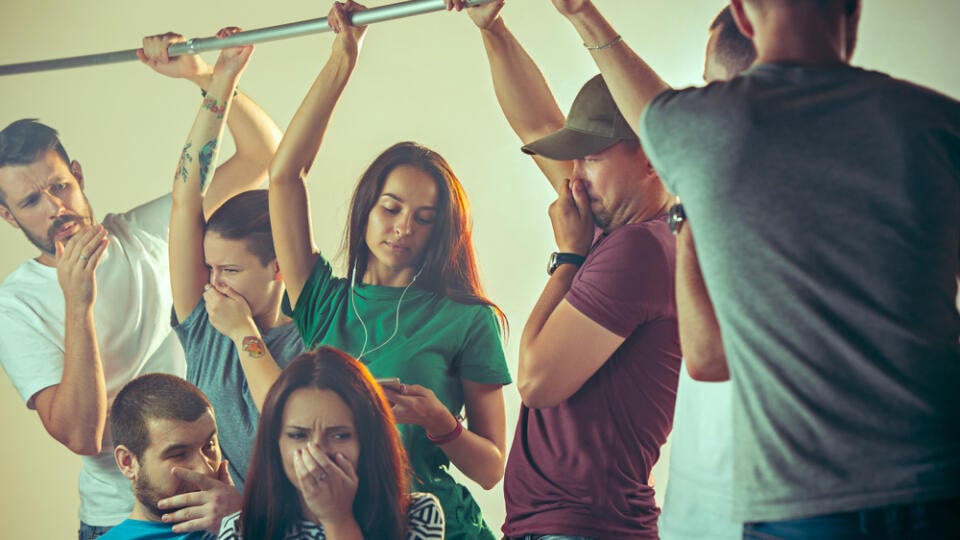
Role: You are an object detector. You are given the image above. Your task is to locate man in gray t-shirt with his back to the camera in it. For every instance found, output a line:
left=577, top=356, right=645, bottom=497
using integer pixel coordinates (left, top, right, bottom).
left=556, top=0, right=960, bottom=538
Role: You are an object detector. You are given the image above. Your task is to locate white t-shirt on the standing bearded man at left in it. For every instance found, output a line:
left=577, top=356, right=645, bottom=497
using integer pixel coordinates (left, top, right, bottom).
left=0, top=195, right=186, bottom=526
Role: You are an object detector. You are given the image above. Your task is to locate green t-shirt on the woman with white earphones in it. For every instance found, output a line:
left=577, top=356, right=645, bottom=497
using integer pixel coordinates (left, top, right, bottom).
left=283, top=258, right=511, bottom=540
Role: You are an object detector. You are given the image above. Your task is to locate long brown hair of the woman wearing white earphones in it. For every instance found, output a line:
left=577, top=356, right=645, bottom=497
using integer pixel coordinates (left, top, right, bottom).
left=345, top=141, right=507, bottom=330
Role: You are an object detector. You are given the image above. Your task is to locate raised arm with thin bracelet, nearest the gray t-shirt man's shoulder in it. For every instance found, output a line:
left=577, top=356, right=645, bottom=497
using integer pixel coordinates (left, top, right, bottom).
left=553, top=0, right=669, bottom=135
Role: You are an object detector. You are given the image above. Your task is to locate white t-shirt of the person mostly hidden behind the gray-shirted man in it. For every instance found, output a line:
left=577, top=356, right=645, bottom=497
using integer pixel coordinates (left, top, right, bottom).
left=658, top=366, right=743, bottom=540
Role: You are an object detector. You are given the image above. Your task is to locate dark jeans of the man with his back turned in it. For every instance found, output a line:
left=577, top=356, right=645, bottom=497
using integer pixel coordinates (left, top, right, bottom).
left=743, top=498, right=960, bottom=540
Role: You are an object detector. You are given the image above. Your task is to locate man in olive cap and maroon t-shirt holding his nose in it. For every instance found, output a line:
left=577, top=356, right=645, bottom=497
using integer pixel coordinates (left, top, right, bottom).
left=468, top=2, right=680, bottom=539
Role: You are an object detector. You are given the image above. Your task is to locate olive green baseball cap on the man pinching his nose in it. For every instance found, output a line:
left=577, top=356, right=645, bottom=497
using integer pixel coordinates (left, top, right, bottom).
left=521, top=75, right=638, bottom=161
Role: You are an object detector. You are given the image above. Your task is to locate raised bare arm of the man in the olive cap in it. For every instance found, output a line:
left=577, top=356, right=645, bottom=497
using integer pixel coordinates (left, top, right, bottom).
left=467, top=0, right=573, bottom=193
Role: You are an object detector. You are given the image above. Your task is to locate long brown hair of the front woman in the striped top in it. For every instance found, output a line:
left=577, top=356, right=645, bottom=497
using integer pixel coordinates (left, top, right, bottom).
left=240, top=347, right=409, bottom=540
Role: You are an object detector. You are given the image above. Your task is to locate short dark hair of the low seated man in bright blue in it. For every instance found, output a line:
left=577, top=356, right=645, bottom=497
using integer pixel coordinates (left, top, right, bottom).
left=110, top=373, right=213, bottom=459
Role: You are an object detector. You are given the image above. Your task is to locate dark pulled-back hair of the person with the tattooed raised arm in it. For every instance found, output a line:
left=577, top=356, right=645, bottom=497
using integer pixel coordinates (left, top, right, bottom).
left=203, top=189, right=277, bottom=265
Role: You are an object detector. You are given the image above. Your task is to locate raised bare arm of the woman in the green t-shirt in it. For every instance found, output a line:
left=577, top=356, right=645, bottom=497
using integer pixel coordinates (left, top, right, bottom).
left=270, top=1, right=366, bottom=306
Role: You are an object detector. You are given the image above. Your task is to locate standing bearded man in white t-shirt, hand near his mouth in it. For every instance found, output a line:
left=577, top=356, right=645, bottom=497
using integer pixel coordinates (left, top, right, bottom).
left=0, top=33, right=280, bottom=540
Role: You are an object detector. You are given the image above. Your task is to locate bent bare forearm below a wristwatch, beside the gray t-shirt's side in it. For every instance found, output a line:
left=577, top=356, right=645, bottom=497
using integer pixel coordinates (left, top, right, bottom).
left=676, top=226, right=730, bottom=381
